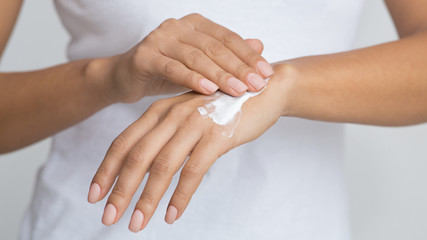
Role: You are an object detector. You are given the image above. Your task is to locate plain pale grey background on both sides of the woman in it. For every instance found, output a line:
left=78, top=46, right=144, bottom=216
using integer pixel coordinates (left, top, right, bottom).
left=0, top=0, right=427, bottom=240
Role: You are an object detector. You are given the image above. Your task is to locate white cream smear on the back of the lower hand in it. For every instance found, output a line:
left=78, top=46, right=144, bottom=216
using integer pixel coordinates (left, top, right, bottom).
left=197, top=78, right=270, bottom=137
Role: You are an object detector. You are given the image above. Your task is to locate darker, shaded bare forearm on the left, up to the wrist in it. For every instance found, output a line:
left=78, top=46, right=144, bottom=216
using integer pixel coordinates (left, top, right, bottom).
left=0, top=57, right=117, bottom=153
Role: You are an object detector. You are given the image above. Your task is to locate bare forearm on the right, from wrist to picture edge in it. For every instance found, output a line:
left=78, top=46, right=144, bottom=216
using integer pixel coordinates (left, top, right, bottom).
left=279, top=32, right=427, bottom=126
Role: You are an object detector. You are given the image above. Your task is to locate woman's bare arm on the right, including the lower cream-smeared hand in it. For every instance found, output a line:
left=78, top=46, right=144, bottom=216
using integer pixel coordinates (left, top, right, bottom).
left=85, top=0, right=427, bottom=232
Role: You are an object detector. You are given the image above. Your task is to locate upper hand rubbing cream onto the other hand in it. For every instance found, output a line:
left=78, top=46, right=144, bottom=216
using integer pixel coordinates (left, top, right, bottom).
left=96, top=14, right=273, bottom=102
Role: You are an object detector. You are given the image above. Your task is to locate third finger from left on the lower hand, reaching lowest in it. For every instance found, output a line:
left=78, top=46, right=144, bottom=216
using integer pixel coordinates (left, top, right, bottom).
left=129, top=127, right=200, bottom=232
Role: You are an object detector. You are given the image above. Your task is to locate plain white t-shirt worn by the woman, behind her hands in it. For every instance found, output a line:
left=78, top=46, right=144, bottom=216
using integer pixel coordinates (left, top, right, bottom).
left=20, top=0, right=363, bottom=240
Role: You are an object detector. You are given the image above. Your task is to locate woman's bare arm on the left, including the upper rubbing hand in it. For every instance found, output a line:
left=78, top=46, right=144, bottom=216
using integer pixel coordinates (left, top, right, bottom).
left=0, top=10, right=273, bottom=153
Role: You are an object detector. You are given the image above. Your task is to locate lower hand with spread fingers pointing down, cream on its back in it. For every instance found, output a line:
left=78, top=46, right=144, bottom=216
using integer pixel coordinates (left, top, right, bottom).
left=88, top=62, right=285, bottom=232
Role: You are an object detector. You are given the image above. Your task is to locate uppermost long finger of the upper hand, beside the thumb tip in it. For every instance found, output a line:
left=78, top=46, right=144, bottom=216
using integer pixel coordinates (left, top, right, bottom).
left=182, top=14, right=274, bottom=78
